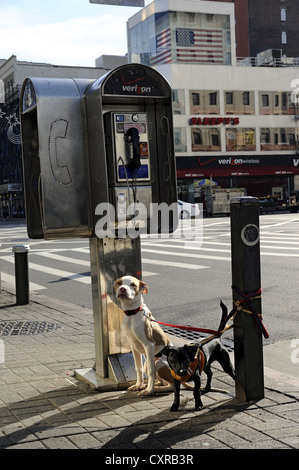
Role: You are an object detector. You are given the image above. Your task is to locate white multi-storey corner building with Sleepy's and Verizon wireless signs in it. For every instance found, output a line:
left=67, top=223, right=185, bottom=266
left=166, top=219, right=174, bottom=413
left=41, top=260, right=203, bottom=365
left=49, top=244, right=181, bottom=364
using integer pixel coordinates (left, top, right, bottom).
left=128, top=0, right=299, bottom=202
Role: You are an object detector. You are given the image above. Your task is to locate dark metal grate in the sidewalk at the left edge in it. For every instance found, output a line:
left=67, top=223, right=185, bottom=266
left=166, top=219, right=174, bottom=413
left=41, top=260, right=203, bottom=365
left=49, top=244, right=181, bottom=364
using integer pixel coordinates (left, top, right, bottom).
left=0, top=321, right=61, bottom=336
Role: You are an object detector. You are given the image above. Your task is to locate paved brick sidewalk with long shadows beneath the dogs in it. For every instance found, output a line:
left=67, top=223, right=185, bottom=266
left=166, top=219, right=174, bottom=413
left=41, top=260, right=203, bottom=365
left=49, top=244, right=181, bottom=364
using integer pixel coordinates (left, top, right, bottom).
left=0, top=283, right=299, bottom=452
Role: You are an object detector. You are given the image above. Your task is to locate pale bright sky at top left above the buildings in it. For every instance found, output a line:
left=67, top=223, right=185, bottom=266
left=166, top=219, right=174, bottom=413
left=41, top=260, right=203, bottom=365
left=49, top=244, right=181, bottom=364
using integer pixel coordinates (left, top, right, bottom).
left=0, top=0, right=150, bottom=67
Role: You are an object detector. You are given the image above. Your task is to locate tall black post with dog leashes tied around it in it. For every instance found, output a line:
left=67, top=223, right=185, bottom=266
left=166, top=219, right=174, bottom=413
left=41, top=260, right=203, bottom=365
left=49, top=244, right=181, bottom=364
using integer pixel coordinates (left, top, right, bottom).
left=230, top=197, right=264, bottom=402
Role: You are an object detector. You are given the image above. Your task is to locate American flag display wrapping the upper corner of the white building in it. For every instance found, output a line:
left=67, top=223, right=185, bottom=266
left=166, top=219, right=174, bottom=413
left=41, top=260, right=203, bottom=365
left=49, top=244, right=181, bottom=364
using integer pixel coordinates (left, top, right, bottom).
left=151, top=28, right=224, bottom=65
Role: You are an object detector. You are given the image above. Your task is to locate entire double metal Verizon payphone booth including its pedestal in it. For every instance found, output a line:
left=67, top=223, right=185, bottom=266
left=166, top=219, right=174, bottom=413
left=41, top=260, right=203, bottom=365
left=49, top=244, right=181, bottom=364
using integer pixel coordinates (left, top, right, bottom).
left=20, top=64, right=178, bottom=390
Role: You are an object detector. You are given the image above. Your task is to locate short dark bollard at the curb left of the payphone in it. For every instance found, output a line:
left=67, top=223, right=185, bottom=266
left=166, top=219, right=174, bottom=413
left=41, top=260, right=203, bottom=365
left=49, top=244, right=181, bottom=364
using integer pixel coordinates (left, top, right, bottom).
left=12, top=245, right=29, bottom=305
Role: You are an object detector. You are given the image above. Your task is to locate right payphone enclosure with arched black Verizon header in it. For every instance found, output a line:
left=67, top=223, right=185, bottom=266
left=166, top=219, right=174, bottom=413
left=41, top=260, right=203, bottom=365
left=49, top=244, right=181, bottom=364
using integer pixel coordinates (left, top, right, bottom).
left=84, top=64, right=177, bottom=233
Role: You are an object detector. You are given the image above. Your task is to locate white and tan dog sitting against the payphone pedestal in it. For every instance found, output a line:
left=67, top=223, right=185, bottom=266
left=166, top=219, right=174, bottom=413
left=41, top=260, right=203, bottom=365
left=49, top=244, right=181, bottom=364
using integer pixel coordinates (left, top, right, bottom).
left=114, top=276, right=171, bottom=395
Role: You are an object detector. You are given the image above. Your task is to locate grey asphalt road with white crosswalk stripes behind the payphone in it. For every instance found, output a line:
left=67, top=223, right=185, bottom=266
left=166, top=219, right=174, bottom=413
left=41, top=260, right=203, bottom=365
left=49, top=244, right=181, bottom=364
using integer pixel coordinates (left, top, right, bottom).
left=0, top=214, right=299, bottom=343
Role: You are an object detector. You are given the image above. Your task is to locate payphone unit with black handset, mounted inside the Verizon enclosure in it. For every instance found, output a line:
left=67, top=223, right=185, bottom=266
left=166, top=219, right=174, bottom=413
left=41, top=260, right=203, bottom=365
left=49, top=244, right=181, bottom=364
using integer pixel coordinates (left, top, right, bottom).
left=107, top=112, right=151, bottom=184
